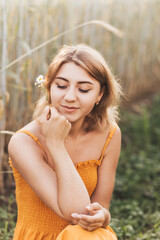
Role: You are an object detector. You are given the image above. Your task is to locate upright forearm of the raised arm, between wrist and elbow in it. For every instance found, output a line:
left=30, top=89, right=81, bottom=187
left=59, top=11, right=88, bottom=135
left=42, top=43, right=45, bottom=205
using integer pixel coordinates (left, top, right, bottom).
left=48, top=144, right=90, bottom=219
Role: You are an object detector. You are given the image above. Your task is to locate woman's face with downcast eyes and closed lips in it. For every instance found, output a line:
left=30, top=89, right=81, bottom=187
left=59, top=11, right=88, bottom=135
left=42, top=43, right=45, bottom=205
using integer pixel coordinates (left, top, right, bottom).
left=50, top=62, right=103, bottom=123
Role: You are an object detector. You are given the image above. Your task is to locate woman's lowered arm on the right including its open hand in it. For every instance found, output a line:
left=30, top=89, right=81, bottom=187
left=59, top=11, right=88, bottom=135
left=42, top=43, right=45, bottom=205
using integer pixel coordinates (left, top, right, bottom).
left=72, top=128, right=121, bottom=231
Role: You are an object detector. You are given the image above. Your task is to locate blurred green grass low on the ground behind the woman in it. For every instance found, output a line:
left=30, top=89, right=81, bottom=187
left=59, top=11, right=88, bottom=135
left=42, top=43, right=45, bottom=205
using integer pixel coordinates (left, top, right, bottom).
left=0, top=97, right=160, bottom=240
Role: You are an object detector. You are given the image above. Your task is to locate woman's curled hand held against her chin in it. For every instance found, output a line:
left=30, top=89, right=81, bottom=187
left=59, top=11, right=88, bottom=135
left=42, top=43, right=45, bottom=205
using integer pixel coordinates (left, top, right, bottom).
left=37, top=106, right=71, bottom=144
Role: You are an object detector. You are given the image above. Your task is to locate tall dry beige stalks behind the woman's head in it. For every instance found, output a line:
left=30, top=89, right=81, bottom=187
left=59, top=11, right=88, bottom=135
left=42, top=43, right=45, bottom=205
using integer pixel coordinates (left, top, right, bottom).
left=0, top=0, right=160, bottom=161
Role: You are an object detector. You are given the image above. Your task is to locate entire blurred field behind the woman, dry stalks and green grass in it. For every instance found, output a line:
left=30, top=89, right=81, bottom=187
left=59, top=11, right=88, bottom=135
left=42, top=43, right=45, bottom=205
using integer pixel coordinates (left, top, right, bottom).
left=0, top=0, right=160, bottom=240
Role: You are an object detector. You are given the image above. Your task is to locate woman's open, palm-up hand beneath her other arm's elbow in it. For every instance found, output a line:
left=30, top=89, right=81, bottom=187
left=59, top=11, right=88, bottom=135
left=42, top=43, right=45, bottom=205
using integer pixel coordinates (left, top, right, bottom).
left=71, top=202, right=110, bottom=231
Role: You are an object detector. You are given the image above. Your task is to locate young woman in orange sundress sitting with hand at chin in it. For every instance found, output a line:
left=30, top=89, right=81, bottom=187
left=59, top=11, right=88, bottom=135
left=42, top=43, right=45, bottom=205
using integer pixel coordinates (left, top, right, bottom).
left=9, top=44, right=121, bottom=240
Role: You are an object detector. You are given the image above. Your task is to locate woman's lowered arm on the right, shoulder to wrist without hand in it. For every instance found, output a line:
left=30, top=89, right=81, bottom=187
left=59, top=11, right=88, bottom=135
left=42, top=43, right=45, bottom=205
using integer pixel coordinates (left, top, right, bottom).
left=91, top=125, right=121, bottom=209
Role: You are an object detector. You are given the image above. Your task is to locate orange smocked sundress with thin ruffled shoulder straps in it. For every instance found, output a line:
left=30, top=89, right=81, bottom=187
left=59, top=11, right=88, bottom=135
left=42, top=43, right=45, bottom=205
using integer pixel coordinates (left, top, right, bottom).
left=9, top=126, right=117, bottom=240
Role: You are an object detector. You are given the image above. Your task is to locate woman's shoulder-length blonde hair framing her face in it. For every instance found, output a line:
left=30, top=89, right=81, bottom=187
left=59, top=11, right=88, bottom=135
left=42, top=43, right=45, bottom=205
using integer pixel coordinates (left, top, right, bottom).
left=33, top=44, right=122, bottom=130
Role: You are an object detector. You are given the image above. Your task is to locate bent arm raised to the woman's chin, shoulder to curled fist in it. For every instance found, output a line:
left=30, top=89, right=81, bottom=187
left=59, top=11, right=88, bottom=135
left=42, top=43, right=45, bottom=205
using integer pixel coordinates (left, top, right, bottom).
left=9, top=109, right=90, bottom=220
